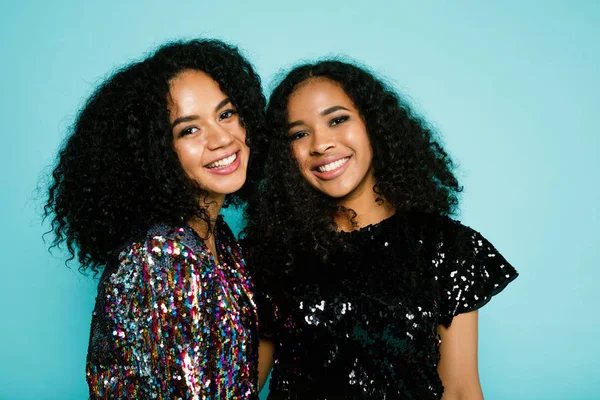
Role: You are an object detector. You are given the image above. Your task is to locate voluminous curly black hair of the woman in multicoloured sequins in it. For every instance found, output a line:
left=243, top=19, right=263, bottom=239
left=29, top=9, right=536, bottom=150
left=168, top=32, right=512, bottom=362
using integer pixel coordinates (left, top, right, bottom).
left=44, top=39, right=266, bottom=274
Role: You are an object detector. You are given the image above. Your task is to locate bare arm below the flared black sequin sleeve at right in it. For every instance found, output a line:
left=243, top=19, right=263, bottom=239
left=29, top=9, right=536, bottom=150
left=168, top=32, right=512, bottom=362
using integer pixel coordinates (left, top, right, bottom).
left=438, top=311, right=483, bottom=400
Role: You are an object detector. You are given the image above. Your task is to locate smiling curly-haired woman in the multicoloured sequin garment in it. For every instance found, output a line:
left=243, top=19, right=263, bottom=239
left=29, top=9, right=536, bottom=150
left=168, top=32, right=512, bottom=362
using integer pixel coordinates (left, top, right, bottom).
left=46, top=40, right=265, bottom=399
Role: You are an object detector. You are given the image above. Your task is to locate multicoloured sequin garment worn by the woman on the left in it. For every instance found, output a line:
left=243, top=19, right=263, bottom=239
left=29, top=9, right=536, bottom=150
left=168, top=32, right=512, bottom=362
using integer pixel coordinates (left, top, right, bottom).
left=87, top=218, right=258, bottom=399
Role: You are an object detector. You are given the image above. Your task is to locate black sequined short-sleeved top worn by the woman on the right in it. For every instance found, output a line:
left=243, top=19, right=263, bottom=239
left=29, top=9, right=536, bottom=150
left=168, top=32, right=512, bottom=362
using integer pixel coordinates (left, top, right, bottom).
left=257, top=214, right=517, bottom=400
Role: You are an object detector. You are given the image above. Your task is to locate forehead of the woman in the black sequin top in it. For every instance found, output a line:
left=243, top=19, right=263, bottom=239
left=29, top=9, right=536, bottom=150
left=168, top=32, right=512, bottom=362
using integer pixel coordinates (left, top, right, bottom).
left=288, top=78, right=354, bottom=114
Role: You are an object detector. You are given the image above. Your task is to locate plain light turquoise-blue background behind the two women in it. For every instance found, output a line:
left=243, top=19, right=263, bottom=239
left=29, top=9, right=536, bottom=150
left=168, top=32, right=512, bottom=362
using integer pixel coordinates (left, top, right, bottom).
left=0, top=0, right=600, bottom=400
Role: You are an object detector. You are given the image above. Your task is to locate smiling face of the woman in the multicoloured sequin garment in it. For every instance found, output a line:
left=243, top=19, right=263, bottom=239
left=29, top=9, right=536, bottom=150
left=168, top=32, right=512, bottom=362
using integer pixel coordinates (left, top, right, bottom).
left=168, top=70, right=250, bottom=202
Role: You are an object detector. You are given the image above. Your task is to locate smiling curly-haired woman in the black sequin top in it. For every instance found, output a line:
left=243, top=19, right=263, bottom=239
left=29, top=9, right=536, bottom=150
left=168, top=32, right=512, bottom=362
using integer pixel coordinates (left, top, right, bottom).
left=245, top=61, right=517, bottom=400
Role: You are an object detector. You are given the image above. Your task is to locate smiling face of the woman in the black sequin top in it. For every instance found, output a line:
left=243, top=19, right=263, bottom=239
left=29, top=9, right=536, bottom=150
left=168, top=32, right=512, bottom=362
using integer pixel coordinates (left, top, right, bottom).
left=288, top=78, right=375, bottom=205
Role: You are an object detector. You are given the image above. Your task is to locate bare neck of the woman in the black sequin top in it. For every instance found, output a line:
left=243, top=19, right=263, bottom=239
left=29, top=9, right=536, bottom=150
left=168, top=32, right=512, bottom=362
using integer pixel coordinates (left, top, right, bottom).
left=334, top=173, right=396, bottom=232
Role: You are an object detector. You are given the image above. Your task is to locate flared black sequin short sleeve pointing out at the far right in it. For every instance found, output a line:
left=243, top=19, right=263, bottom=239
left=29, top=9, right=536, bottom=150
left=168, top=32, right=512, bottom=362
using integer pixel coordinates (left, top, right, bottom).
left=434, top=220, right=518, bottom=327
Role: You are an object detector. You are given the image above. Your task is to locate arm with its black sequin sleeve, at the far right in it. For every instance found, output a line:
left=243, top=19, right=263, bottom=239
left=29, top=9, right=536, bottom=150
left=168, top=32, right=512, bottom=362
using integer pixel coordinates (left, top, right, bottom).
left=435, top=219, right=518, bottom=400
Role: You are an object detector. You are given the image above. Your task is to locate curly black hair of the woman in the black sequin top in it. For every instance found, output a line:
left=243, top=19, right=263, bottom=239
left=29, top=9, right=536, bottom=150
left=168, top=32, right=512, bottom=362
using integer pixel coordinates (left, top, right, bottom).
left=244, top=60, right=462, bottom=276
